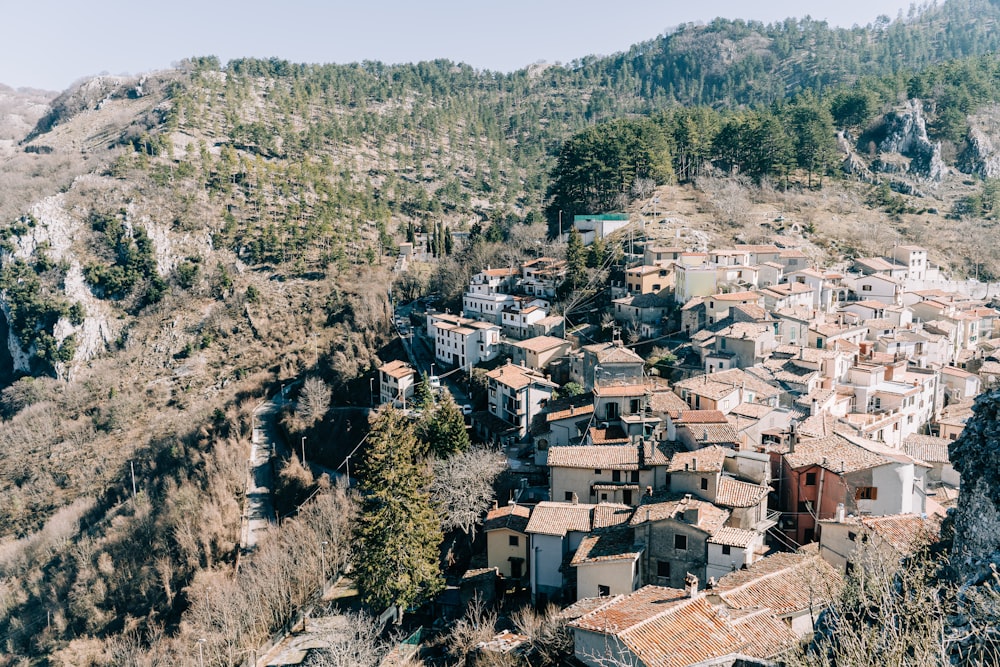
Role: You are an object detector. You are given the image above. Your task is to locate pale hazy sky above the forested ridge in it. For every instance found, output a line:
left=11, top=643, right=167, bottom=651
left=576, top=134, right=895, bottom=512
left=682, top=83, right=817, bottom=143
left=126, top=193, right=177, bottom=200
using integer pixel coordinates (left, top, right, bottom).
left=0, top=0, right=910, bottom=90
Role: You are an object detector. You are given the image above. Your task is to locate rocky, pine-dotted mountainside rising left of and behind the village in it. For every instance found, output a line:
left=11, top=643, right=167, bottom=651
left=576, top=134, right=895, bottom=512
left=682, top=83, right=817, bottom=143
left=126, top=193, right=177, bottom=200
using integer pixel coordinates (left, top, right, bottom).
left=0, top=0, right=1000, bottom=665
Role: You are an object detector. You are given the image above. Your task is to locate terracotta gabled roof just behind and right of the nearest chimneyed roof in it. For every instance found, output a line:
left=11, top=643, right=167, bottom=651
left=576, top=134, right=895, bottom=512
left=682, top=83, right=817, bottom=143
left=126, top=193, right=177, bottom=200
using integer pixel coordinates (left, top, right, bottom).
left=714, top=548, right=843, bottom=616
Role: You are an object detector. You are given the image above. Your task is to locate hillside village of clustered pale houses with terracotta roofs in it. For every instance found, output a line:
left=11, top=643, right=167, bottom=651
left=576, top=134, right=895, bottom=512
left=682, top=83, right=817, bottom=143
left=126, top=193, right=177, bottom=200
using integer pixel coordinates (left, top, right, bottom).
left=372, top=215, right=1000, bottom=667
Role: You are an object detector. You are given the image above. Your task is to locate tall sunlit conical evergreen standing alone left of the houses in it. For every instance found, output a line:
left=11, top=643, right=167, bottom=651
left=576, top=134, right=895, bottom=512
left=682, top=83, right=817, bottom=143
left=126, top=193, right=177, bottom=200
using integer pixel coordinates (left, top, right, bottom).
left=354, top=407, right=444, bottom=611
